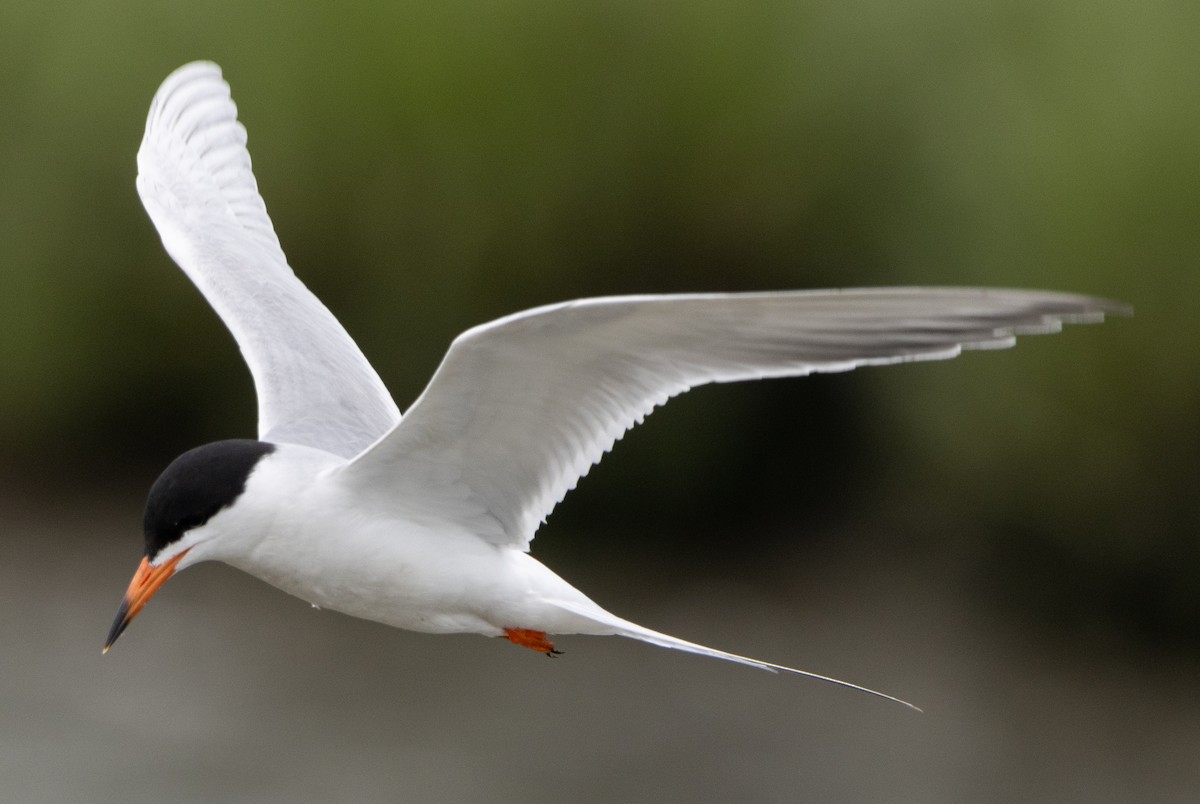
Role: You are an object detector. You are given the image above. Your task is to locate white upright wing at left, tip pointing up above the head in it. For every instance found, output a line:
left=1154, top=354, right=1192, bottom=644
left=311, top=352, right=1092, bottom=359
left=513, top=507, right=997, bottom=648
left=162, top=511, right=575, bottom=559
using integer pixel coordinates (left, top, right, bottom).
left=138, top=62, right=400, bottom=457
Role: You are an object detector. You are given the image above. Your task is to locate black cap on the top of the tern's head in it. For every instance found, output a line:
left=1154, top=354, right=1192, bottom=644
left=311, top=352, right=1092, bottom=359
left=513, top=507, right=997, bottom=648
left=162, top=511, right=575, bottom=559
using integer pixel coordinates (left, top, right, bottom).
left=144, top=439, right=275, bottom=560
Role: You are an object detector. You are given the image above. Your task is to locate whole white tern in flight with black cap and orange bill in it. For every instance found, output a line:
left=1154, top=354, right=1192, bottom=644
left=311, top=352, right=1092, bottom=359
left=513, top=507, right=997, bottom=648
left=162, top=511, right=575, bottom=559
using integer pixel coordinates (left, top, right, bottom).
left=104, top=62, right=1128, bottom=708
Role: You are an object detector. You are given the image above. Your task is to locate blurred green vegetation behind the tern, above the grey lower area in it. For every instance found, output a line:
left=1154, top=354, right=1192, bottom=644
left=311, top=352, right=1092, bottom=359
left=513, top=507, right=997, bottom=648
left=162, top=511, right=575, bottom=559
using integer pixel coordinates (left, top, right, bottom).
left=0, top=0, right=1200, bottom=641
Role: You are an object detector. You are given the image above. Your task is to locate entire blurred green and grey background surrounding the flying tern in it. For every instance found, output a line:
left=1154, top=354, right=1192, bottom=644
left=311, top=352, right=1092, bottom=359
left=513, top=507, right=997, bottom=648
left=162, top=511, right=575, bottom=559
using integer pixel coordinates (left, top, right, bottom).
left=0, top=0, right=1200, bottom=802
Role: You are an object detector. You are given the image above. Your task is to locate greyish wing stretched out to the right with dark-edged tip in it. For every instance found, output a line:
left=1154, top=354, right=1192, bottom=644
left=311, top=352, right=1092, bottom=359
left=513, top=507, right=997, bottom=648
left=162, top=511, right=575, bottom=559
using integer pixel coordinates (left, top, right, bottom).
left=341, top=288, right=1129, bottom=550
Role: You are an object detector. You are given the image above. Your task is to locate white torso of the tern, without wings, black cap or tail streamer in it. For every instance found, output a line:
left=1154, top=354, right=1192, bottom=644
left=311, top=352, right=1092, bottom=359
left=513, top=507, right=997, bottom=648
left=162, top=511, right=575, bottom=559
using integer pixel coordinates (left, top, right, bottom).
left=202, top=445, right=616, bottom=636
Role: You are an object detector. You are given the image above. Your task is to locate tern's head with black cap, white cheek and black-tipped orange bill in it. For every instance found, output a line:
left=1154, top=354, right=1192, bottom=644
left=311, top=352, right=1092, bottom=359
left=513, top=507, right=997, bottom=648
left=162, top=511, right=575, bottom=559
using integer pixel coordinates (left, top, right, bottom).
left=104, top=439, right=275, bottom=653
